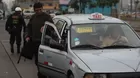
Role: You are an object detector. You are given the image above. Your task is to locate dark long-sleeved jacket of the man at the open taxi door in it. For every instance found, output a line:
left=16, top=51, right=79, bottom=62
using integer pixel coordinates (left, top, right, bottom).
left=26, top=12, right=53, bottom=41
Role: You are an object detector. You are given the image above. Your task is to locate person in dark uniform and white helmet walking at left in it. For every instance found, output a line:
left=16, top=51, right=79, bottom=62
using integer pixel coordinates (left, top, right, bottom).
left=5, top=7, right=26, bottom=54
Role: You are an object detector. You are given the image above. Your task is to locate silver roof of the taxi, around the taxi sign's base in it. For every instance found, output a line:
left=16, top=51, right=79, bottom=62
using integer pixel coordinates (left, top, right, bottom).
left=54, top=14, right=124, bottom=25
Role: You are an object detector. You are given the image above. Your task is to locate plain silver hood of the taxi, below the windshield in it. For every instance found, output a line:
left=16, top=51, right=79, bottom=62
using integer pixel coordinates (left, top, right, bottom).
left=73, top=49, right=140, bottom=73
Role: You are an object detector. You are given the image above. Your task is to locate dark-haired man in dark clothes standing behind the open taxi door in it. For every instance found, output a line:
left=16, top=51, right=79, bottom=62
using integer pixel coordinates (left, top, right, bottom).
left=26, top=2, right=53, bottom=78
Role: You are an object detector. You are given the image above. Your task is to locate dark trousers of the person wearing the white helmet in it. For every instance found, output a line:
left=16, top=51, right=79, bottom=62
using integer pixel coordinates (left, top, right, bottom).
left=10, top=32, right=21, bottom=46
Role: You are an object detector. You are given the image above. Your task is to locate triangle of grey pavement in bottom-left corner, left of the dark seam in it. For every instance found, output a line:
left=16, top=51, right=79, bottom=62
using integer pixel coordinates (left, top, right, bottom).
left=0, top=42, right=21, bottom=78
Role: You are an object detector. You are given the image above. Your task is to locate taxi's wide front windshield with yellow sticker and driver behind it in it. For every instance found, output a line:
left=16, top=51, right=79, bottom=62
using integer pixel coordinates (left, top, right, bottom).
left=71, top=24, right=140, bottom=49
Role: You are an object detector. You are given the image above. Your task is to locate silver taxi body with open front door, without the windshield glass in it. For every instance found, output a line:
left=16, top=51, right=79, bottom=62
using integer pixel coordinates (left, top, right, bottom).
left=38, top=14, right=140, bottom=78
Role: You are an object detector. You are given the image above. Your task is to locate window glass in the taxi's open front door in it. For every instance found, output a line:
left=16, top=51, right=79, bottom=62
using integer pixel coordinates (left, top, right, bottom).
left=41, top=25, right=59, bottom=46
